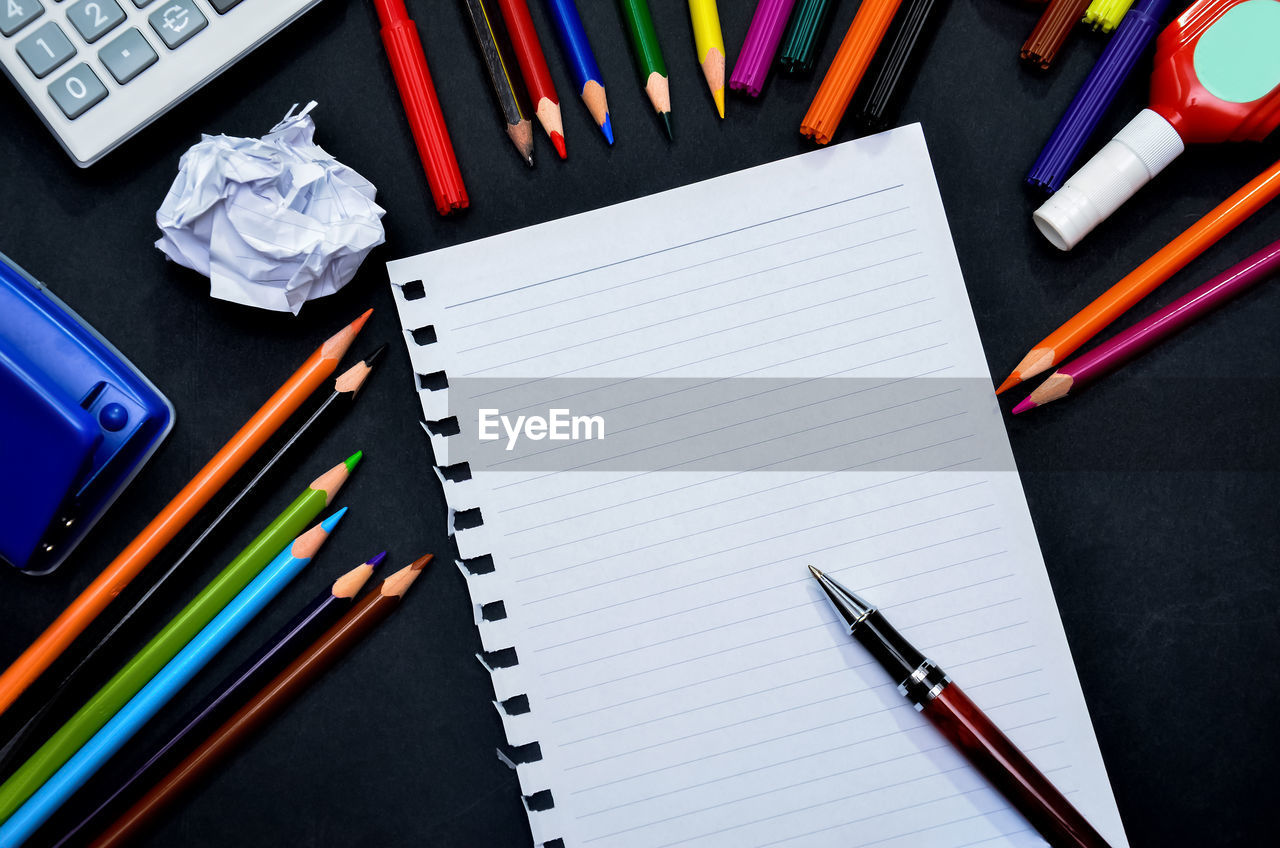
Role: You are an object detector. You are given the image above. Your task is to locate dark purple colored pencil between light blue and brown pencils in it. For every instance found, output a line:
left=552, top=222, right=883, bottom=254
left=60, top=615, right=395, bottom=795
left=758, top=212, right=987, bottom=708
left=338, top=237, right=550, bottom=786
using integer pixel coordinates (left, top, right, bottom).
left=49, top=551, right=387, bottom=848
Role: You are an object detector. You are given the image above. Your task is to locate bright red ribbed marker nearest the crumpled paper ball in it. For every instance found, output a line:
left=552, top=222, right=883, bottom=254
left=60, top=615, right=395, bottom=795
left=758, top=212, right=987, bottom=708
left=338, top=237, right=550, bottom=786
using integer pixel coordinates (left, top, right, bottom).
left=374, top=0, right=471, bottom=215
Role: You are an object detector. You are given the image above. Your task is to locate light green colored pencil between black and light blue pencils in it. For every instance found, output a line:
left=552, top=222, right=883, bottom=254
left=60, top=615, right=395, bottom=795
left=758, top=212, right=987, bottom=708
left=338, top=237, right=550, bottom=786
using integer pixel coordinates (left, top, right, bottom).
left=0, top=452, right=361, bottom=821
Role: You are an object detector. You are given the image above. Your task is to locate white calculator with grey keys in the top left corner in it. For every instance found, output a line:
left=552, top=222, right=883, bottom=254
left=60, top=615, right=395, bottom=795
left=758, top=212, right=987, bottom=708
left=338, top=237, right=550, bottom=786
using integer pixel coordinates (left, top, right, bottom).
left=0, top=0, right=320, bottom=168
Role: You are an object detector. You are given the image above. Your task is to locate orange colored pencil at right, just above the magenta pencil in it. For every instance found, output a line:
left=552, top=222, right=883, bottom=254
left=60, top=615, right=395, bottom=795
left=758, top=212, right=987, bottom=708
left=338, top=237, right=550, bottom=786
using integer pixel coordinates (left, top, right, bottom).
left=996, top=161, right=1280, bottom=395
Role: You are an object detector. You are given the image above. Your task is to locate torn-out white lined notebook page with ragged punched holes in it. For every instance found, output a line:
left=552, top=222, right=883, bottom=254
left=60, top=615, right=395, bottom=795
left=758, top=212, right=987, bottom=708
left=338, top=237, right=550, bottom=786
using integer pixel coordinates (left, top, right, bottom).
left=389, top=126, right=1125, bottom=848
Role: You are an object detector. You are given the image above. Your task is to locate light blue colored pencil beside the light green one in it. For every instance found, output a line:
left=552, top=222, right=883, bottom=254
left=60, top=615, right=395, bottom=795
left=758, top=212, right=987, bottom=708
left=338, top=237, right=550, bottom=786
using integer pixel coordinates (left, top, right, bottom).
left=0, top=507, right=347, bottom=848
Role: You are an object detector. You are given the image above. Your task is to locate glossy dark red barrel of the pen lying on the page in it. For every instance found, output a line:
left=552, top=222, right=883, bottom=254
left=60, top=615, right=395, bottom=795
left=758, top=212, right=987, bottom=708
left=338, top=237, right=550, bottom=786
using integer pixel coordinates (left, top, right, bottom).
left=923, top=683, right=1110, bottom=848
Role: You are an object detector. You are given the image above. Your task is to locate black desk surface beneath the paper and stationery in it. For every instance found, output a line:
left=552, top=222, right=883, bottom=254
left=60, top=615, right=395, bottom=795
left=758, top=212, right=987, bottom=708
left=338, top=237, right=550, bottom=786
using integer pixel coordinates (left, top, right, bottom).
left=0, top=0, right=1280, bottom=848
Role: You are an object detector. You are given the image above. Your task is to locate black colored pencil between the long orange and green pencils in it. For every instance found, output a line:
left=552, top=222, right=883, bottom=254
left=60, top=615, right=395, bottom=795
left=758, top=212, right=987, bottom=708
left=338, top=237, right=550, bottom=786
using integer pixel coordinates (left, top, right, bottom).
left=0, top=345, right=387, bottom=775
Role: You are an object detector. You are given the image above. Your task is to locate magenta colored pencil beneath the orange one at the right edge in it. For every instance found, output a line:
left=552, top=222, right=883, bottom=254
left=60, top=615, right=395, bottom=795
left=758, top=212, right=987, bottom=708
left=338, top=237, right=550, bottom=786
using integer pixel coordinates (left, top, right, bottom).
left=1014, top=241, right=1280, bottom=415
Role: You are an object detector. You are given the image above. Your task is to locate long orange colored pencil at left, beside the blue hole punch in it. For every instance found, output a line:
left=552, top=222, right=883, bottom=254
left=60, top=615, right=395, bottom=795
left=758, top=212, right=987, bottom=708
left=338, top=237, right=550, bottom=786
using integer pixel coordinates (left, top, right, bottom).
left=0, top=310, right=374, bottom=713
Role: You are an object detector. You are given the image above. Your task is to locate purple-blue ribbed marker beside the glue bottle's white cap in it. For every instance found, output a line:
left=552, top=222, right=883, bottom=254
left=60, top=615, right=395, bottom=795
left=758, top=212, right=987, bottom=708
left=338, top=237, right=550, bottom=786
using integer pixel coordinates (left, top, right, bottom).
left=1027, top=0, right=1170, bottom=193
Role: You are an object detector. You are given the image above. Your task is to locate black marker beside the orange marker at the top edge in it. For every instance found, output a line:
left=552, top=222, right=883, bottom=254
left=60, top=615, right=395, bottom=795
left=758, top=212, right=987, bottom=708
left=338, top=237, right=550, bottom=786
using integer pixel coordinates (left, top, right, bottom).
left=854, top=0, right=947, bottom=132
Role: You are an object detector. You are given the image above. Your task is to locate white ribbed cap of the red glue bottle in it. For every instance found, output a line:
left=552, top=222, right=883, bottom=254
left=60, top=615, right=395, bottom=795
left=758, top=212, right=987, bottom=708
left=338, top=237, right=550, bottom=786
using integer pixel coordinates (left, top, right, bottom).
left=1032, top=109, right=1184, bottom=250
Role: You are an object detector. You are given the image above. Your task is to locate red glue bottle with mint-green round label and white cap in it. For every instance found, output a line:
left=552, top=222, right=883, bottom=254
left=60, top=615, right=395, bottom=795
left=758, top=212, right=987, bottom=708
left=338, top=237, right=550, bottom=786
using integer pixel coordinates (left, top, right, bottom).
left=1033, top=0, right=1280, bottom=250
